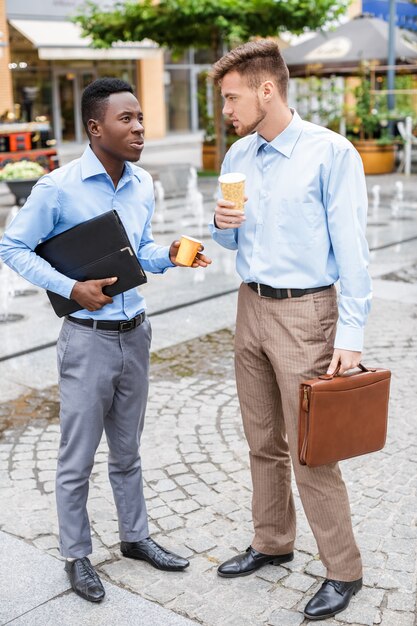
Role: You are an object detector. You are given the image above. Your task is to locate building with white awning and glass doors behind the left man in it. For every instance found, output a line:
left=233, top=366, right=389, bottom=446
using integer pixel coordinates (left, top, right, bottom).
left=0, top=0, right=211, bottom=145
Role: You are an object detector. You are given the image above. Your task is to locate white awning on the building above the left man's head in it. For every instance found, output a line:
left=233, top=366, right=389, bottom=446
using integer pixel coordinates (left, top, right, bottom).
left=9, top=19, right=159, bottom=61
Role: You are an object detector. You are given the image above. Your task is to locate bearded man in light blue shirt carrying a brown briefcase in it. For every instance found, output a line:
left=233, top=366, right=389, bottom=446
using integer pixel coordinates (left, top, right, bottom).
left=211, top=40, right=371, bottom=619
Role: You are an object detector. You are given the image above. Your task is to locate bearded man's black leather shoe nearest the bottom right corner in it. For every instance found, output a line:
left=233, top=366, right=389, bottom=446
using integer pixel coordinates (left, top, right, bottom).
left=304, top=578, right=362, bottom=620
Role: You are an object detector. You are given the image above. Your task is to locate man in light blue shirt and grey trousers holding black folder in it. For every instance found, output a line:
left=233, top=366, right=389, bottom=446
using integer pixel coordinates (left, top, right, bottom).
left=0, top=78, right=211, bottom=602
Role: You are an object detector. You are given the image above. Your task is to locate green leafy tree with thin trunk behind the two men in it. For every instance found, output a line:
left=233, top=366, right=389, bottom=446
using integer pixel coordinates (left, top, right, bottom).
left=75, top=0, right=349, bottom=166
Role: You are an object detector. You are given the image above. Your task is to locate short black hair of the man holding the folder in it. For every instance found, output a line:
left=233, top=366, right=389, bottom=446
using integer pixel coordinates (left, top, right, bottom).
left=81, top=77, right=133, bottom=135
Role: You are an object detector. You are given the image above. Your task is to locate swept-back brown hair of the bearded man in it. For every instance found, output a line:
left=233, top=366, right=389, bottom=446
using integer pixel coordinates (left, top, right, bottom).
left=211, top=39, right=289, bottom=102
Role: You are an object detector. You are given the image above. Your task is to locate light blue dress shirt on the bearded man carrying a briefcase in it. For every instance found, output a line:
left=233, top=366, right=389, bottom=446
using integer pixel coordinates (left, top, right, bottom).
left=210, top=111, right=372, bottom=351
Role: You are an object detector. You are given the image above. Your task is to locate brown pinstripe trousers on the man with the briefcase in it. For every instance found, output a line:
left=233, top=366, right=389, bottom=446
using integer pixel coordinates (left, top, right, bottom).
left=235, top=284, right=362, bottom=581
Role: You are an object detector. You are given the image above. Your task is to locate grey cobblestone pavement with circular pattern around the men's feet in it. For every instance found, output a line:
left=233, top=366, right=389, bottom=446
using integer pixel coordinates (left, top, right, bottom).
left=0, top=300, right=417, bottom=626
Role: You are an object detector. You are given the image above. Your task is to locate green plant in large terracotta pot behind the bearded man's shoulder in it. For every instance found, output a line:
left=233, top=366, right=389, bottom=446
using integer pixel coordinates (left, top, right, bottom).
left=348, top=72, right=395, bottom=174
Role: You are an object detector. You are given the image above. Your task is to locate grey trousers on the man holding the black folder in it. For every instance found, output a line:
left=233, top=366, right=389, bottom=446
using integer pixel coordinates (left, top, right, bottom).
left=56, top=319, right=152, bottom=558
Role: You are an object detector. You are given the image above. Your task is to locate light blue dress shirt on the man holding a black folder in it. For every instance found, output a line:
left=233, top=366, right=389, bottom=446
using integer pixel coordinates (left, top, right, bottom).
left=0, top=147, right=173, bottom=320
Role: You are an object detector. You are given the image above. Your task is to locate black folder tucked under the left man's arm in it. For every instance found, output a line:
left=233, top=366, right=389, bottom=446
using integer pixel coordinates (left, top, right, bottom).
left=35, top=211, right=147, bottom=317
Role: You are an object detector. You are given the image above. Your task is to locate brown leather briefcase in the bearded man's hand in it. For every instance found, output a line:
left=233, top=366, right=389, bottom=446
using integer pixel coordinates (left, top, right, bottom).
left=298, top=365, right=391, bottom=467
